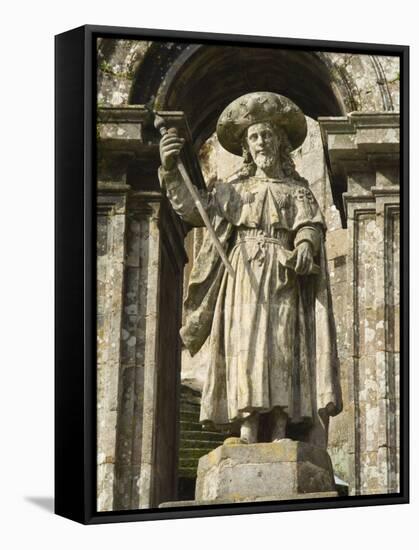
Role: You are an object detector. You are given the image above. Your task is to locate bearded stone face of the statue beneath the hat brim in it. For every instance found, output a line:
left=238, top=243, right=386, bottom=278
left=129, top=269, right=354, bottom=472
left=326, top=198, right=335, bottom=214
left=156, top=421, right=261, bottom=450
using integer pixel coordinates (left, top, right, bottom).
left=245, top=122, right=279, bottom=170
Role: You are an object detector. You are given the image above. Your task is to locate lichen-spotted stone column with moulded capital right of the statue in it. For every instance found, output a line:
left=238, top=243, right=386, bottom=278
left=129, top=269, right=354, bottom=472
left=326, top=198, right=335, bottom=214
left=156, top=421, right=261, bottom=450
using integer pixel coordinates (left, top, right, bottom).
left=319, top=112, right=400, bottom=494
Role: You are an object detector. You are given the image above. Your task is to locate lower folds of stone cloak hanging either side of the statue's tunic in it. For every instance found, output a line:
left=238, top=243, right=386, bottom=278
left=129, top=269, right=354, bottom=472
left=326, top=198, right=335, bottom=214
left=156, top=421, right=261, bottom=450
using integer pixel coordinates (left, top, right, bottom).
left=180, top=183, right=342, bottom=426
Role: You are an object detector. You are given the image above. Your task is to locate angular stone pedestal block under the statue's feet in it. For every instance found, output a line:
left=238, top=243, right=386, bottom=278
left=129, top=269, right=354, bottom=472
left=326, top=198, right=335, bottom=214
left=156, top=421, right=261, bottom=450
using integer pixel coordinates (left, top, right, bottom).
left=195, top=439, right=336, bottom=502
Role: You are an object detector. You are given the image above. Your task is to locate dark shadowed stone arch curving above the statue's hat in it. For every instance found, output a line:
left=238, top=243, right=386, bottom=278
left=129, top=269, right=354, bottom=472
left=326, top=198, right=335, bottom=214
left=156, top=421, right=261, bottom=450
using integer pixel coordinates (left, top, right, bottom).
left=134, top=44, right=348, bottom=144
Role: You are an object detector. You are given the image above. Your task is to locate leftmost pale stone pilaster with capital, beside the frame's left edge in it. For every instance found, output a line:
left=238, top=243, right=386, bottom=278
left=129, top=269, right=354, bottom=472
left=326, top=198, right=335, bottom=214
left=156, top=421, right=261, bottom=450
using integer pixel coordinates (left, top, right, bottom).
left=96, top=109, right=148, bottom=511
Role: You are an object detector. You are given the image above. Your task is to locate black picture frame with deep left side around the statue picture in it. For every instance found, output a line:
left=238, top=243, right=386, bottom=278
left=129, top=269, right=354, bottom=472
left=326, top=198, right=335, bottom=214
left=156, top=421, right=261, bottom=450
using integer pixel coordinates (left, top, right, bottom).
left=55, top=25, right=409, bottom=524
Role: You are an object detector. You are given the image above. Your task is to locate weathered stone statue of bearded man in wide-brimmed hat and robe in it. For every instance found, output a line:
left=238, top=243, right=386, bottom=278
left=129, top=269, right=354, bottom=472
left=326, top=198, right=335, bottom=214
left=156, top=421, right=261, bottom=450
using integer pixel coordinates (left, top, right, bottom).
left=159, top=92, right=342, bottom=448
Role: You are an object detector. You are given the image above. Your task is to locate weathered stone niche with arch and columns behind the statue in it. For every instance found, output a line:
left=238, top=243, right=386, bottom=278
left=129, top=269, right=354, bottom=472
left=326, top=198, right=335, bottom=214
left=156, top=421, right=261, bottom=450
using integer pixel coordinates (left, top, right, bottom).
left=97, top=40, right=400, bottom=511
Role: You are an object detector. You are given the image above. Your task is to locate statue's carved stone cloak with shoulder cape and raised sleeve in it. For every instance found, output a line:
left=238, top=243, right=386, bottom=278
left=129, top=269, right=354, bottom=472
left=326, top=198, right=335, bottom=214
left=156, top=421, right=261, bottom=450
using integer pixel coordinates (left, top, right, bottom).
left=159, top=166, right=342, bottom=434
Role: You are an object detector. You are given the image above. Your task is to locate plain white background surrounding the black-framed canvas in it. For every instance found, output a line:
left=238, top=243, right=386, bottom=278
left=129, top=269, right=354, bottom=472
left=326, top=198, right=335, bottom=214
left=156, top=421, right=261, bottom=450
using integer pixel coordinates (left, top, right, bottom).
left=0, top=0, right=419, bottom=550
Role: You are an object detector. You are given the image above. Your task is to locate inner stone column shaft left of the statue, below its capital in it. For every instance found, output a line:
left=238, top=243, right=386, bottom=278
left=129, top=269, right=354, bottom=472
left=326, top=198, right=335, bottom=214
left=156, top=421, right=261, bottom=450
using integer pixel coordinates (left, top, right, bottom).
left=114, top=191, right=186, bottom=509
